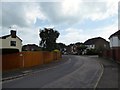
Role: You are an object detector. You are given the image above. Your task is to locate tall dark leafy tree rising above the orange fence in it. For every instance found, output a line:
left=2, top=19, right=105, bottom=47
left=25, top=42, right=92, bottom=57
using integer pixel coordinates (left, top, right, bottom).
left=39, top=28, right=60, bottom=51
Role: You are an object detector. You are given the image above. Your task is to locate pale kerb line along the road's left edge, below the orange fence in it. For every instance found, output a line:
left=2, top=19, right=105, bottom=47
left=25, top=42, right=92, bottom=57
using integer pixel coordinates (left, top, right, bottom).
left=2, top=58, right=71, bottom=83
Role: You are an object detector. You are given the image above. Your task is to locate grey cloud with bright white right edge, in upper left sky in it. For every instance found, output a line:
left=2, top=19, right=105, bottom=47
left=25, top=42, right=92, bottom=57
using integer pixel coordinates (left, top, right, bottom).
left=1, top=2, right=42, bottom=27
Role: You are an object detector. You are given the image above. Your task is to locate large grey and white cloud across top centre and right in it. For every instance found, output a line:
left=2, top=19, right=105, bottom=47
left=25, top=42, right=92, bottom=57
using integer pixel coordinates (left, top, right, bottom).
left=39, top=2, right=107, bottom=25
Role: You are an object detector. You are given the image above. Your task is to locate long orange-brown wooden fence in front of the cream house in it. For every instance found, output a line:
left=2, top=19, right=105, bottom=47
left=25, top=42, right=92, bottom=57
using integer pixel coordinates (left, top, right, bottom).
left=0, top=51, right=61, bottom=71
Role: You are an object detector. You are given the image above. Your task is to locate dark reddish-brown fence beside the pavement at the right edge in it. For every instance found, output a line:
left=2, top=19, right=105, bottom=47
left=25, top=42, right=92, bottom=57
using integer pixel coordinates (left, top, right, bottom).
left=102, top=48, right=120, bottom=62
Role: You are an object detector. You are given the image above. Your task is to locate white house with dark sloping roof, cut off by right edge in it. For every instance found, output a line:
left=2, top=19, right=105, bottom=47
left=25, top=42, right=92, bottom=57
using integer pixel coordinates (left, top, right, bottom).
left=109, top=30, right=120, bottom=48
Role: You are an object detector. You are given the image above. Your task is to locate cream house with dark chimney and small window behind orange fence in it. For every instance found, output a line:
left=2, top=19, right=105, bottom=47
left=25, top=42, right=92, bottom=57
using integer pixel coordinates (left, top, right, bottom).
left=0, top=30, right=22, bottom=52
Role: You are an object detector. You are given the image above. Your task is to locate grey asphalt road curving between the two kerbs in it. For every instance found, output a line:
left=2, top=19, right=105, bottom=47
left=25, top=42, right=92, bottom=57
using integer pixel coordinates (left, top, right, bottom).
left=2, top=55, right=103, bottom=88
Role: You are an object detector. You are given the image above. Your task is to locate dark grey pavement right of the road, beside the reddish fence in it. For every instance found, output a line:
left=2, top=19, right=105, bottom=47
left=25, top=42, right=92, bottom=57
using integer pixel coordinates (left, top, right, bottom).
left=89, top=57, right=120, bottom=90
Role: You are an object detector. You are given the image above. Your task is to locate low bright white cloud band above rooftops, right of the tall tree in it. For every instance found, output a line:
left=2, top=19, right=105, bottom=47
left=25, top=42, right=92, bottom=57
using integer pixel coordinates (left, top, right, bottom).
left=57, top=22, right=118, bottom=45
